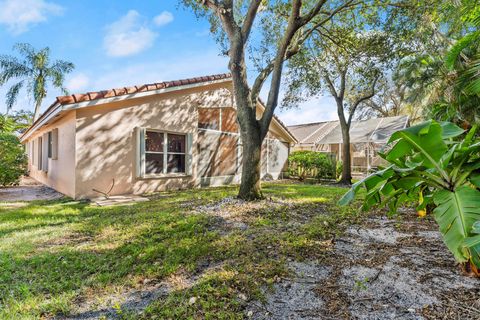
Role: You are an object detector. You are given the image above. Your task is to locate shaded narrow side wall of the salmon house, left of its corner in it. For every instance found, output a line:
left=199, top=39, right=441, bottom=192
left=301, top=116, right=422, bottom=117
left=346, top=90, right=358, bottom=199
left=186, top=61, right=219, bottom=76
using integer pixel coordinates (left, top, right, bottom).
left=24, top=111, right=76, bottom=197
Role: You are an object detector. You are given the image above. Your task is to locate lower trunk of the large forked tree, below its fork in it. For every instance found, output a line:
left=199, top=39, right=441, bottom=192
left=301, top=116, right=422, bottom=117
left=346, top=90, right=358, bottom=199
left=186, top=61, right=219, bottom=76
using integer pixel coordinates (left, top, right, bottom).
left=238, top=127, right=263, bottom=201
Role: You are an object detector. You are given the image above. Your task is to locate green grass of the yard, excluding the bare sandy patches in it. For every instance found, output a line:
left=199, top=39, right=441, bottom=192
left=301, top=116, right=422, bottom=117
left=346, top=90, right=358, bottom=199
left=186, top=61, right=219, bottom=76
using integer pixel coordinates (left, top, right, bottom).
left=0, top=184, right=361, bottom=319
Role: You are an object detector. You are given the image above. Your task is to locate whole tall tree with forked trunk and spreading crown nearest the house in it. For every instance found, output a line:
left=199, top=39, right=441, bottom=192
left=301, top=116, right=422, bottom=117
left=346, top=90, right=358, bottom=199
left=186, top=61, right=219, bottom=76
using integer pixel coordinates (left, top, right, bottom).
left=181, top=0, right=366, bottom=200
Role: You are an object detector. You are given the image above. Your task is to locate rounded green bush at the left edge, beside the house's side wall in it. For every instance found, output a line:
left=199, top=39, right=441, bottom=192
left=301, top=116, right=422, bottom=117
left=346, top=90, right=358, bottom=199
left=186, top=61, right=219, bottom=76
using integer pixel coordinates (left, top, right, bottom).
left=0, top=133, right=27, bottom=186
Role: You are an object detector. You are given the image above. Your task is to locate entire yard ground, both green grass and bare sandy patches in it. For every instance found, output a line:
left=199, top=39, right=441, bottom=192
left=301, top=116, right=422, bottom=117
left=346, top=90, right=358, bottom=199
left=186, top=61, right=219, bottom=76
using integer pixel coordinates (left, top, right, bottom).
left=0, top=182, right=480, bottom=320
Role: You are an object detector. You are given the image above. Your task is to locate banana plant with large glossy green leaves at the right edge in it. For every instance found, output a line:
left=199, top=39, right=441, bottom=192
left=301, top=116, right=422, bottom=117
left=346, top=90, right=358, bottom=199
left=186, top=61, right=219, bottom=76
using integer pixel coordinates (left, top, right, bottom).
left=339, top=120, right=480, bottom=276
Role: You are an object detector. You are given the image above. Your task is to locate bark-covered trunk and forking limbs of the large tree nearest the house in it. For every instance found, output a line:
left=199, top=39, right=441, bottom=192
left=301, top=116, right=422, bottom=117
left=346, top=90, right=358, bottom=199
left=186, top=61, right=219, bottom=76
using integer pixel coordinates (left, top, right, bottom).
left=200, top=0, right=327, bottom=201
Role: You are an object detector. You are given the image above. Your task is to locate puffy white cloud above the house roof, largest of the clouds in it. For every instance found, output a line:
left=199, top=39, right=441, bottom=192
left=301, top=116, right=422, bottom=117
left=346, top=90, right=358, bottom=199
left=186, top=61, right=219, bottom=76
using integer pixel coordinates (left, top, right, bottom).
left=103, top=10, right=157, bottom=57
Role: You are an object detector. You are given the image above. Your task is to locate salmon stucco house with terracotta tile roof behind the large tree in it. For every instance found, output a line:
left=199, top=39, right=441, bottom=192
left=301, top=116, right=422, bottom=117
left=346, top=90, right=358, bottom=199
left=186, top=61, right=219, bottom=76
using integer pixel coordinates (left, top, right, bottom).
left=21, top=74, right=296, bottom=199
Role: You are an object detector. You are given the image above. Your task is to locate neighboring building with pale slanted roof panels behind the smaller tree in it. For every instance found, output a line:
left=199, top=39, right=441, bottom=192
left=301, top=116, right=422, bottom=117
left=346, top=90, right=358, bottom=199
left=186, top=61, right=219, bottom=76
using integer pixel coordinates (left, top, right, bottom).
left=288, top=116, right=409, bottom=172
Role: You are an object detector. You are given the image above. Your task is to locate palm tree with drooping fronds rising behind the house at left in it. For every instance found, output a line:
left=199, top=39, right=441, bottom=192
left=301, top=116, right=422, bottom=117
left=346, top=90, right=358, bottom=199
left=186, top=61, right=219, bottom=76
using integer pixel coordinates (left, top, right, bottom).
left=0, top=43, right=75, bottom=121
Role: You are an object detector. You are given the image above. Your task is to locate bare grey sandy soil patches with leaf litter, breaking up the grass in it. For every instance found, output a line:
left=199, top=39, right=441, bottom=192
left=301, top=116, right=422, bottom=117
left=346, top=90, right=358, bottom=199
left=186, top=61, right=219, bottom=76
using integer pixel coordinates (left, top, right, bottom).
left=53, top=198, right=480, bottom=320
